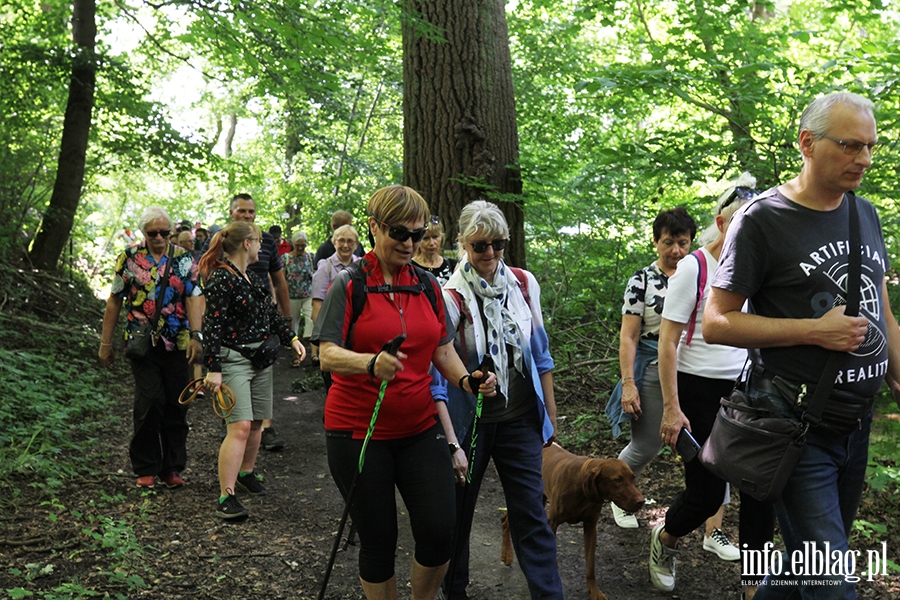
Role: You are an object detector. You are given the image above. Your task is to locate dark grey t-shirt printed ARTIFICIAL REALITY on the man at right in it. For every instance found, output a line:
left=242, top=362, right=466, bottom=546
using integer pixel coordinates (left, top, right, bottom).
left=712, top=188, right=890, bottom=396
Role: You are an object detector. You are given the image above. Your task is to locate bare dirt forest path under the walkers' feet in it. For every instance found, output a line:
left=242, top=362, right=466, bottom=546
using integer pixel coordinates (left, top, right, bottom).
left=119, top=346, right=739, bottom=600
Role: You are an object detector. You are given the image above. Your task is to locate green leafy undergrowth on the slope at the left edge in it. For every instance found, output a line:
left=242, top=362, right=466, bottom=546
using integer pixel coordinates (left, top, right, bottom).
left=0, top=267, right=126, bottom=488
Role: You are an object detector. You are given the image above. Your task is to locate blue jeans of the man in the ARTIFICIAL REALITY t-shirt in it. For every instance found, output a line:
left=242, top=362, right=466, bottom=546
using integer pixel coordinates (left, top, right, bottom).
left=750, top=390, right=872, bottom=600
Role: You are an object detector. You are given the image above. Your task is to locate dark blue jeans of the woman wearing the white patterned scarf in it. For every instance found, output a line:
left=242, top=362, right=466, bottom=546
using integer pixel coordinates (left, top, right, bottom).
left=444, top=408, right=563, bottom=600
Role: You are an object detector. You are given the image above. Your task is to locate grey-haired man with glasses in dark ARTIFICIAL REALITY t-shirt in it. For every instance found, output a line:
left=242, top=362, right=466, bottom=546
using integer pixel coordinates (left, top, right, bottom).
left=704, top=93, right=900, bottom=600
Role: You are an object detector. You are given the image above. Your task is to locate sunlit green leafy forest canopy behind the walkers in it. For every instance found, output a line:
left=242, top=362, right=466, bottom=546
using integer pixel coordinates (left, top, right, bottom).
left=0, top=0, right=900, bottom=310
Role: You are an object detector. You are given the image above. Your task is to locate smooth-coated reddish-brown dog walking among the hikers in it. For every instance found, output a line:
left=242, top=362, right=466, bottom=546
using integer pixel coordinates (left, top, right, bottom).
left=500, top=443, right=644, bottom=600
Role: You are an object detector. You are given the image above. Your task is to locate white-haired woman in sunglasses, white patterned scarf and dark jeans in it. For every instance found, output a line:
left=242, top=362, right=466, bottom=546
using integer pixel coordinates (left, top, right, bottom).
left=436, top=200, right=563, bottom=600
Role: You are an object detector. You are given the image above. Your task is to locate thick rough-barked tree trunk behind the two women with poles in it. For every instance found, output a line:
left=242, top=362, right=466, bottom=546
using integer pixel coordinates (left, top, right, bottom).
left=403, top=0, right=525, bottom=266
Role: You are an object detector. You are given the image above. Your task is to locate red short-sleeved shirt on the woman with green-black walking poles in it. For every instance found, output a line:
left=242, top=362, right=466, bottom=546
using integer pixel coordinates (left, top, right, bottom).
left=313, top=252, right=453, bottom=440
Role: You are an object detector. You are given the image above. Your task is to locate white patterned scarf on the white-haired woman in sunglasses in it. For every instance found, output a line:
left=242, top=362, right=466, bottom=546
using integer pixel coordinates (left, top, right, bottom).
left=445, top=258, right=531, bottom=402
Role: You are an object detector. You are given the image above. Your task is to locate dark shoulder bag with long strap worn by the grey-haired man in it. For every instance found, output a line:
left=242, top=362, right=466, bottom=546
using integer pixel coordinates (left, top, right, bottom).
left=700, top=192, right=862, bottom=502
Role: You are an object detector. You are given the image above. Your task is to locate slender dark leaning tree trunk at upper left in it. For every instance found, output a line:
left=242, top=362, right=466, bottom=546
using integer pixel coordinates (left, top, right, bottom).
left=30, top=0, right=97, bottom=270
